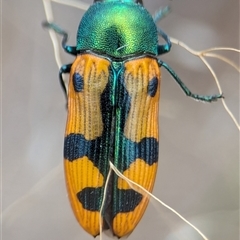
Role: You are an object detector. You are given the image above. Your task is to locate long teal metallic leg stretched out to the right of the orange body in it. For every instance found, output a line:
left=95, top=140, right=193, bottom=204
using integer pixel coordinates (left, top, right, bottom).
left=158, top=59, right=223, bottom=102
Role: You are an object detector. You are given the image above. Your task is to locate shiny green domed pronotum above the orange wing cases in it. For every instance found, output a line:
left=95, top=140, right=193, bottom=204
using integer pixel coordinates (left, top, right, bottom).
left=76, top=1, right=158, bottom=58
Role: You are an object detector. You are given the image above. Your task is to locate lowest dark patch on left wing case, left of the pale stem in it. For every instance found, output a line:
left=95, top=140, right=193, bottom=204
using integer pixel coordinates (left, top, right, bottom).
left=77, top=187, right=103, bottom=211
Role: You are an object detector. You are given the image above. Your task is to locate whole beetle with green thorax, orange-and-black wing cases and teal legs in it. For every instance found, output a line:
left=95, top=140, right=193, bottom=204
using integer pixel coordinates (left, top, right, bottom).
left=44, top=0, right=223, bottom=238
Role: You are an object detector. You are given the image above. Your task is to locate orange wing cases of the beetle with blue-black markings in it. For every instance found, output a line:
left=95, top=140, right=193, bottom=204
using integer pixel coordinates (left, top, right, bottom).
left=64, top=54, right=160, bottom=237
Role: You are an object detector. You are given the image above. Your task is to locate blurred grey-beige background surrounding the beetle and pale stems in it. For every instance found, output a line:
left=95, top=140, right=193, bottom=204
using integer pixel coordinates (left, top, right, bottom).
left=1, top=0, right=239, bottom=240
